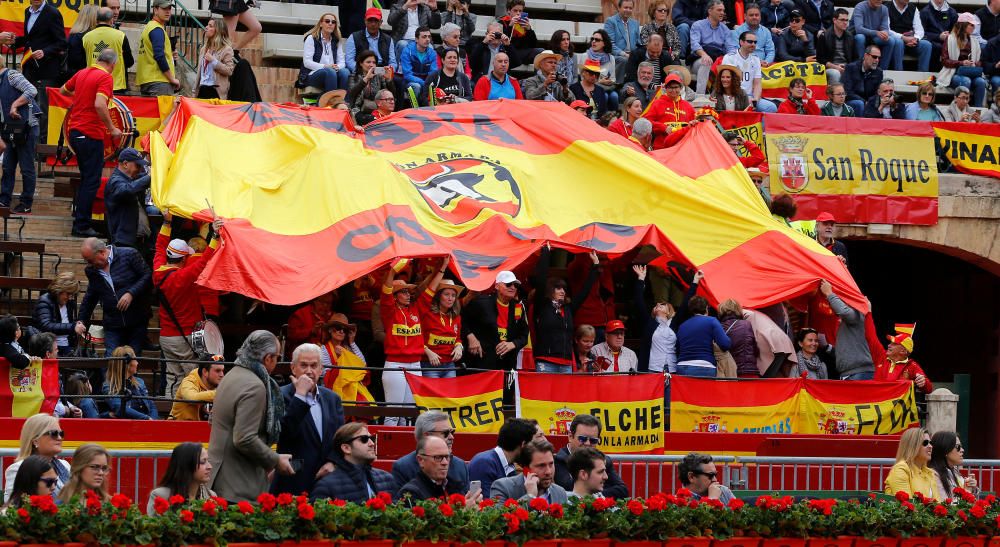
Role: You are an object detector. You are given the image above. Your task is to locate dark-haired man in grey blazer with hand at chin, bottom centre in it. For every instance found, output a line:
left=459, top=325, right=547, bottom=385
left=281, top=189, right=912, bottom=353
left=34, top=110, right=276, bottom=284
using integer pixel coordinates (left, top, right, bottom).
left=484, top=441, right=568, bottom=505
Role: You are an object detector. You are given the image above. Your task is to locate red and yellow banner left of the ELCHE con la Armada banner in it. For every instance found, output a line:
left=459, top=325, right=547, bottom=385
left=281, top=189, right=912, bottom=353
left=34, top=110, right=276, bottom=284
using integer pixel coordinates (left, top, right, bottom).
left=406, top=371, right=503, bottom=433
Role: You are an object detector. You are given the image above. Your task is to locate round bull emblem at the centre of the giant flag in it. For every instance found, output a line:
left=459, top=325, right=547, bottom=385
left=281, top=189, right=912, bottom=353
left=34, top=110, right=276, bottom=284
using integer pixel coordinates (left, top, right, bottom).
left=396, top=158, right=521, bottom=225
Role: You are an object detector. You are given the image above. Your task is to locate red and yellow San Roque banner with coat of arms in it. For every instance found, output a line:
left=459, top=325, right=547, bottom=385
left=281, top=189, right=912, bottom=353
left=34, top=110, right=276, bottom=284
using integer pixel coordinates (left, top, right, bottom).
left=764, top=114, right=938, bottom=225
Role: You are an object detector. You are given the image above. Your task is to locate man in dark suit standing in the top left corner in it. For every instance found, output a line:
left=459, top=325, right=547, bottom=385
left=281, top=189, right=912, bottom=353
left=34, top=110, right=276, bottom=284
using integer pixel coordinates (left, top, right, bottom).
left=0, top=0, right=69, bottom=142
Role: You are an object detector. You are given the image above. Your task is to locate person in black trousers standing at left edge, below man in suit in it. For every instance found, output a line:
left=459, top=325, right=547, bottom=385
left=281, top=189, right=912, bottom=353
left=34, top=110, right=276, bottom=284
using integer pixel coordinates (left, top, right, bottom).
left=0, top=68, right=41, bottom=214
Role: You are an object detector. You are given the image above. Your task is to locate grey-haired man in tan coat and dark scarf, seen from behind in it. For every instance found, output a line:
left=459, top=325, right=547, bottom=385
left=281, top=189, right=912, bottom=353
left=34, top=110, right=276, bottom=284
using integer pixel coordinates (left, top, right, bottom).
left=208, top=330, right=295, bottom=501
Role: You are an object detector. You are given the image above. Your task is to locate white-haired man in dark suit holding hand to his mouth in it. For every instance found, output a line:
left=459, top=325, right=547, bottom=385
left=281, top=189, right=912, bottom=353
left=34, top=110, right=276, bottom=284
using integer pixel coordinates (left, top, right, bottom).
left=271, top=344, right=344, bottom=495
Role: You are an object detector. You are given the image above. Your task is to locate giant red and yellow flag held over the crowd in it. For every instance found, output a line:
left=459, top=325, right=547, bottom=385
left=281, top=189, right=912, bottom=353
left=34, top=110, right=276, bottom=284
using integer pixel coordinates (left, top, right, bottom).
left=150, top=99, right=867, bottom=311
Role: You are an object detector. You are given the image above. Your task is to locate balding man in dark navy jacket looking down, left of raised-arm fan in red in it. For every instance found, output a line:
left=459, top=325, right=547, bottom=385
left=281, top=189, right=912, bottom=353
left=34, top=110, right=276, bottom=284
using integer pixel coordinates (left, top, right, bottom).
left=80, top=237, right=153, bottom=356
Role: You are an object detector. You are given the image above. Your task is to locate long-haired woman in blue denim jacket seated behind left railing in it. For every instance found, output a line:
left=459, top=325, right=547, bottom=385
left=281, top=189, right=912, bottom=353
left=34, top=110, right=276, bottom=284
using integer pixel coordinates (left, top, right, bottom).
left=101, top=346, right=159, bottom=420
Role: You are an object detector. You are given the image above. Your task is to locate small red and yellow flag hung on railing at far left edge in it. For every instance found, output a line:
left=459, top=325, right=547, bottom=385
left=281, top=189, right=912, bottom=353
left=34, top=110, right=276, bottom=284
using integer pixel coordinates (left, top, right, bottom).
left=0, top=357, right=59, bottom=418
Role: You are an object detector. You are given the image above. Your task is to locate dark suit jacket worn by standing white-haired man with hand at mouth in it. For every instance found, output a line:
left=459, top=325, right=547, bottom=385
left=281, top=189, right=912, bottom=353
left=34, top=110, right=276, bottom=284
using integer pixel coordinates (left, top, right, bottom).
left=271, top=384, right=344, bottom=495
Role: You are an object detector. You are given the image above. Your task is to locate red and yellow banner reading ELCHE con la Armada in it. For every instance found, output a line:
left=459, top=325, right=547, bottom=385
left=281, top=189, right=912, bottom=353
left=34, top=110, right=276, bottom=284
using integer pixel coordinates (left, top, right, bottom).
left=516, top=372, right=666, bottom=454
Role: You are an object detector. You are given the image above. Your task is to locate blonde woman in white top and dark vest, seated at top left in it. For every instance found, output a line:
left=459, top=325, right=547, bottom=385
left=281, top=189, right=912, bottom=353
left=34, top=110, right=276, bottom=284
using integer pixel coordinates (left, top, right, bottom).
left=298, top=13, right=350, bottom=93
